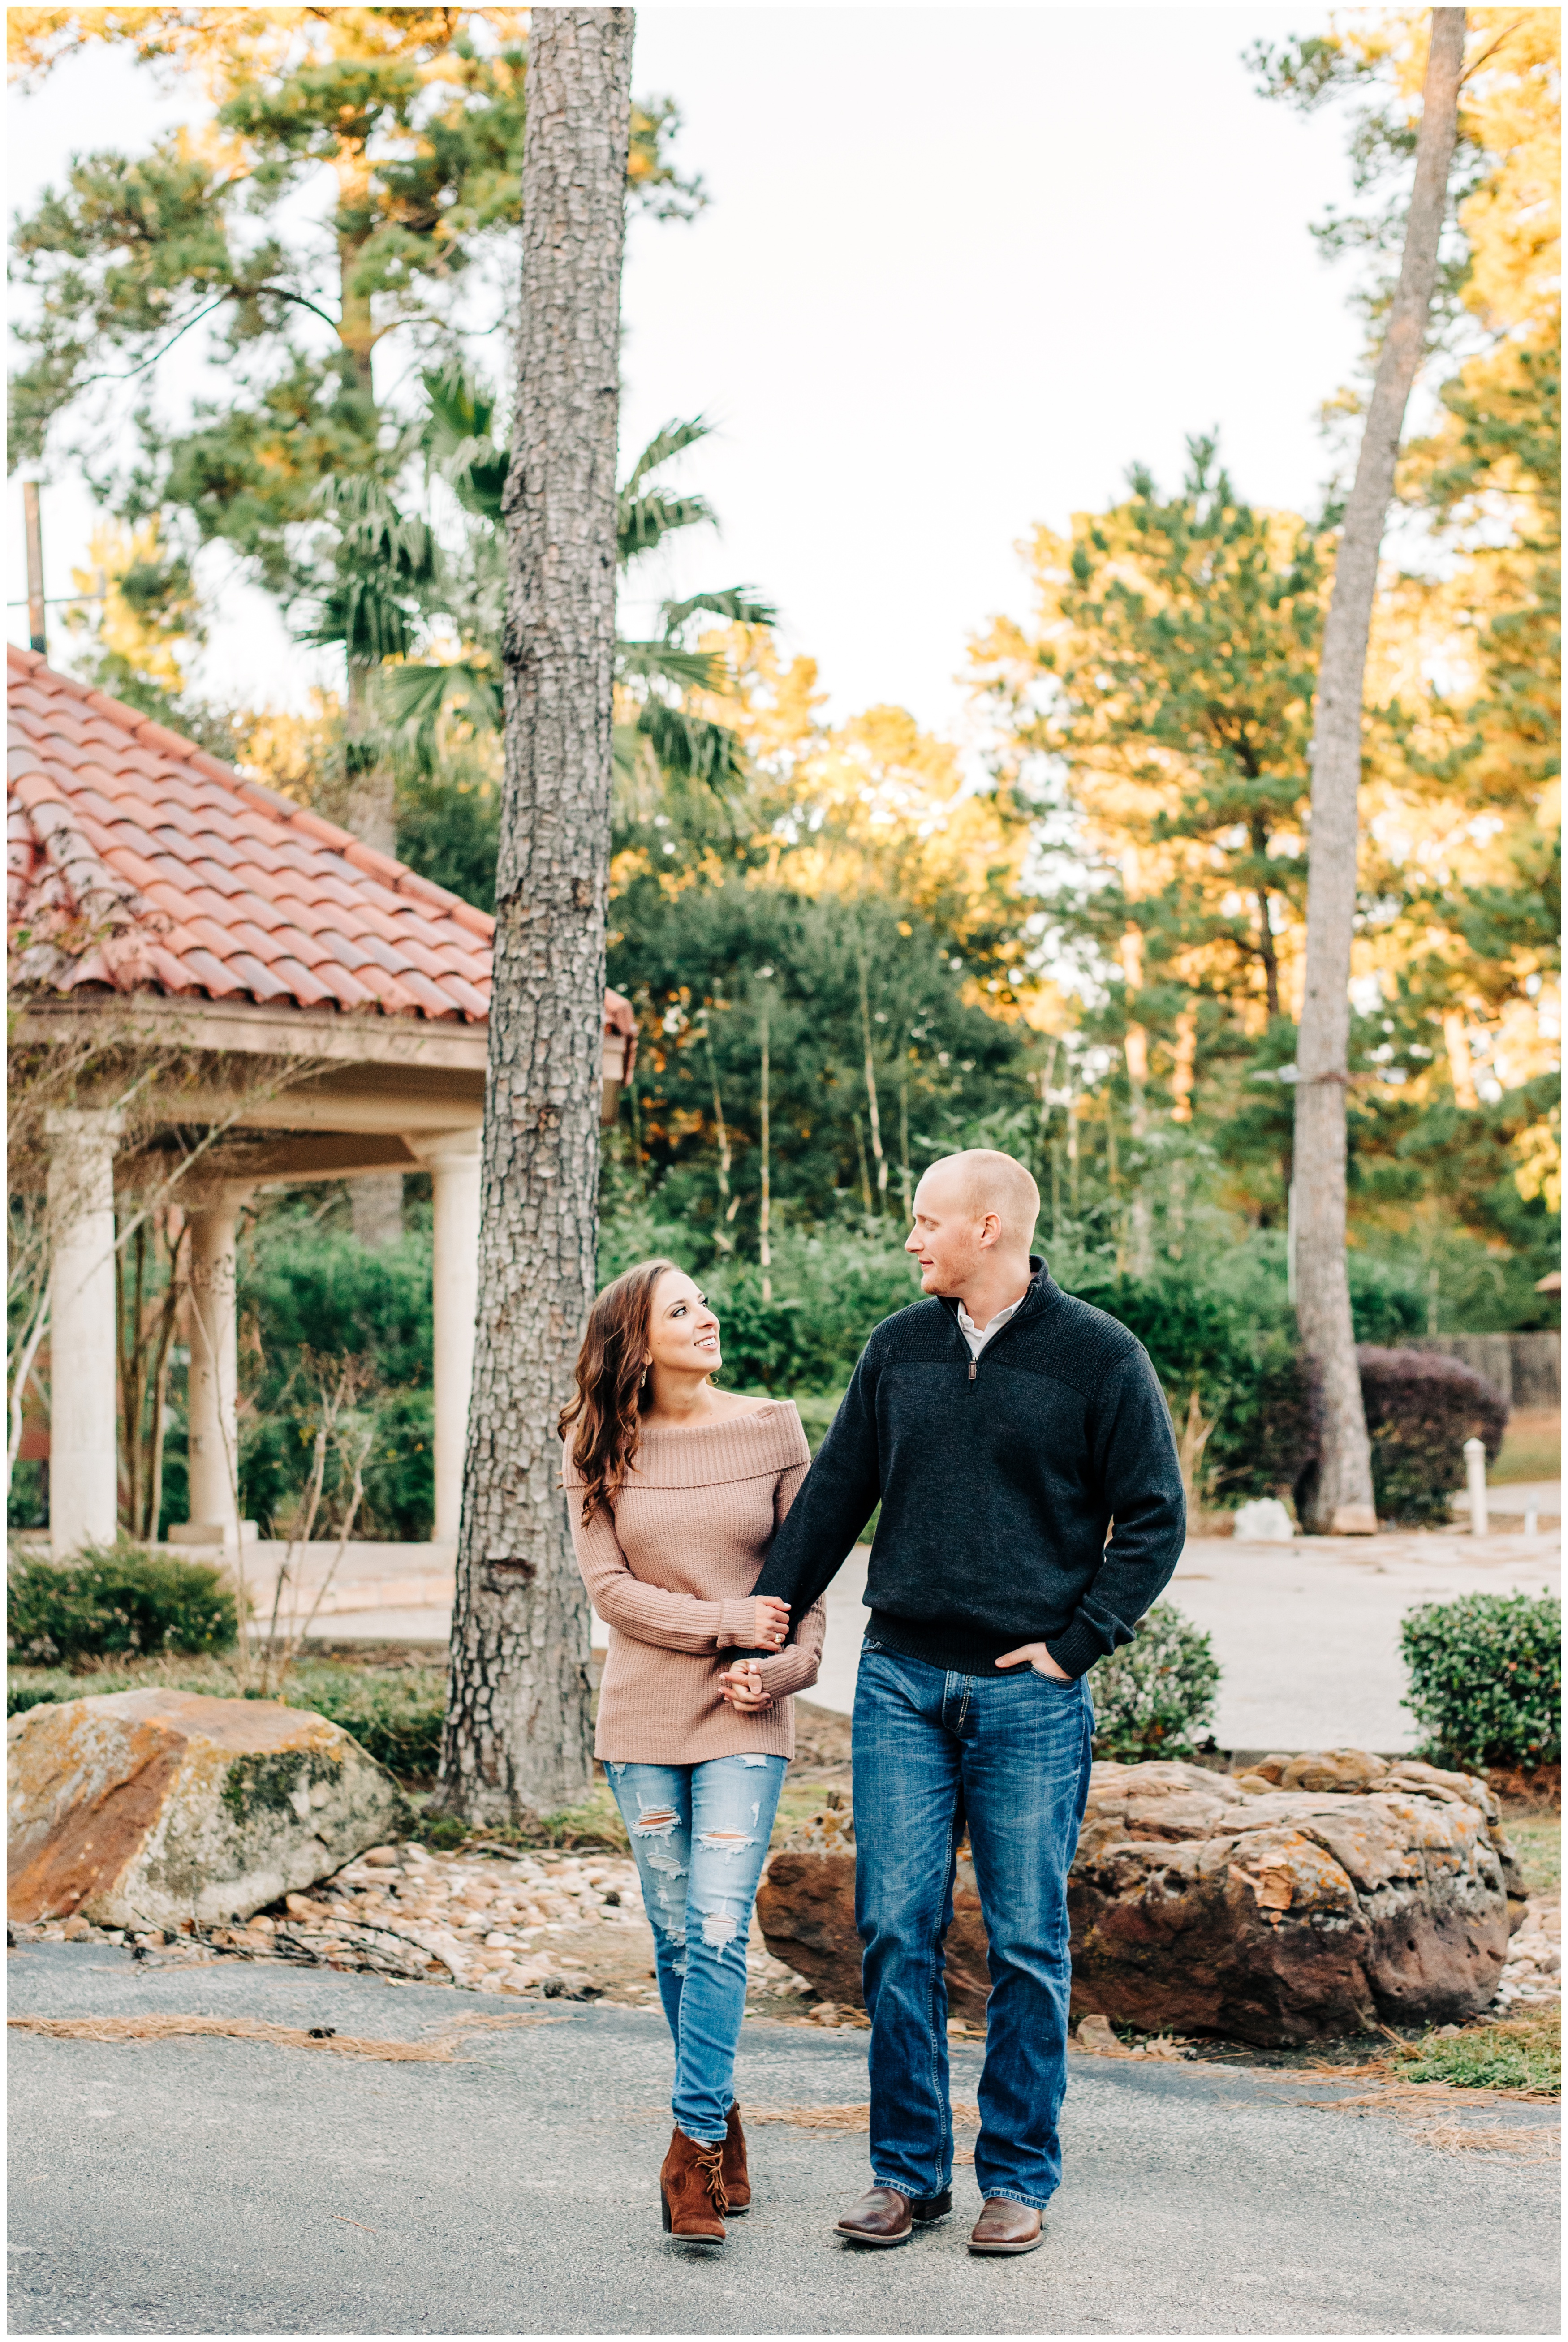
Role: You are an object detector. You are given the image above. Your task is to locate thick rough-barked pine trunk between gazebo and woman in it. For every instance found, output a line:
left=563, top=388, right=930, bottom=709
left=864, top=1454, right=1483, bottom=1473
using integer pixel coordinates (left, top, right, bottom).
left=441, top=7, right=633, bottom=1822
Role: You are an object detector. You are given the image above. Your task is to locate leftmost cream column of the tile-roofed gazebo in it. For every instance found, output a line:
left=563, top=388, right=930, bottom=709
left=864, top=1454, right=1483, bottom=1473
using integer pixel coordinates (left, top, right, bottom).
left=44, top=1108, right=124, bottom=1560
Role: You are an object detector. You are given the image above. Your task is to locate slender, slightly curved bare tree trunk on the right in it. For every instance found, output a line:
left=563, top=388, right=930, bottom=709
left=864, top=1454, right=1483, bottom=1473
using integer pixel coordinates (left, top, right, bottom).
left=1294, top=7, right=1465, bottom=1537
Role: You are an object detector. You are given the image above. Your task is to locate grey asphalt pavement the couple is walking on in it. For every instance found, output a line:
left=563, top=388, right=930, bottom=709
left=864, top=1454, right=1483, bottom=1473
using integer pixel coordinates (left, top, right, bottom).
left=9, top=1944, right=1559, bottom=2335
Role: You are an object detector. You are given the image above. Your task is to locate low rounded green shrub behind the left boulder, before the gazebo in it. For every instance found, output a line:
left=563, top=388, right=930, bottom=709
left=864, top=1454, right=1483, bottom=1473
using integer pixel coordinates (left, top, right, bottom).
left=7, top=1539, right=239, bottom=1665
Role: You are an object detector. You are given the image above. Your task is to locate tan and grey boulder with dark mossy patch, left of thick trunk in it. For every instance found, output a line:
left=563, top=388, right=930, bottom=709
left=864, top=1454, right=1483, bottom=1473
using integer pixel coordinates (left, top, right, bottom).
left=7, top=1691, right=401, bottom=1930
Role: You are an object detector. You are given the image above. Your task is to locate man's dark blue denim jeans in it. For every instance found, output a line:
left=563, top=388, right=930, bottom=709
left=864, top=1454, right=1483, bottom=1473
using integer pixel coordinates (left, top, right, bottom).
left=856, top=1640, right=1094, bottom=2209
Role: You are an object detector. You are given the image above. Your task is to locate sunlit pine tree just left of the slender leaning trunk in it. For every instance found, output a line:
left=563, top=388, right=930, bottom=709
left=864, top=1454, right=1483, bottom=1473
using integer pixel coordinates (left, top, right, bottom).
left=970, top=440, right=1329, bottom=1213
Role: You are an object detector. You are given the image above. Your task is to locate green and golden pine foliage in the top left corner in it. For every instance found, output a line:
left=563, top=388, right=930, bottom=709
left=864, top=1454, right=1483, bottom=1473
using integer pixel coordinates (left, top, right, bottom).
left=7, top=7, right=701, bottom=607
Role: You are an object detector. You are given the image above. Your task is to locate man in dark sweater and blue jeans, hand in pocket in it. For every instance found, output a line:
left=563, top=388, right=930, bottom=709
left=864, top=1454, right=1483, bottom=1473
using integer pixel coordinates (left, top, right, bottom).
left=731, top=1148, right=1186, bottom=2253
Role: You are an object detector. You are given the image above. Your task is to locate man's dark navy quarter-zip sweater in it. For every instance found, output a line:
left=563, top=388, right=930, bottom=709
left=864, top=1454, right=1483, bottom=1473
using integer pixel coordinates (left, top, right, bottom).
left=755, top=1260, right=1186, bottom=1677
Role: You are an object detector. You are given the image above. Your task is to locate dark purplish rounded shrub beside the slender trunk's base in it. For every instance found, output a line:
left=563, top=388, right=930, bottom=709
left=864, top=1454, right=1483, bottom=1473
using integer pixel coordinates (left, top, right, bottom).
left=1355, top=1347, right=1509, bottom=1527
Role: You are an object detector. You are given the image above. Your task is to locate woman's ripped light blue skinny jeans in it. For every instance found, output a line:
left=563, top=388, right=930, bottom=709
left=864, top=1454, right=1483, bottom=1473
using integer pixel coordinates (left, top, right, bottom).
left=605, top=1756, right=785, bottom=2148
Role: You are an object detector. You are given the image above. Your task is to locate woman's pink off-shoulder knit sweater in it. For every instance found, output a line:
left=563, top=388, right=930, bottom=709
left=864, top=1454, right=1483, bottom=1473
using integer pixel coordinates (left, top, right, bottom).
left=563, top=1400, right=827, bottom=1764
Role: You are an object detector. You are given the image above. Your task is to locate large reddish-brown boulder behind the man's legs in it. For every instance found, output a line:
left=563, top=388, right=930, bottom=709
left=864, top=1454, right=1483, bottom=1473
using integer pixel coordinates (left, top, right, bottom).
left=757, top=1749, right=1524, bottom=2045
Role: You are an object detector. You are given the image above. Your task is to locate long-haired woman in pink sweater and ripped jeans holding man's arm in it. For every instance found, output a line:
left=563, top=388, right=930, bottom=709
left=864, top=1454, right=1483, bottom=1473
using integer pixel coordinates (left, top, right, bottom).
left=560, top=1260, right=825, bottom=2243
